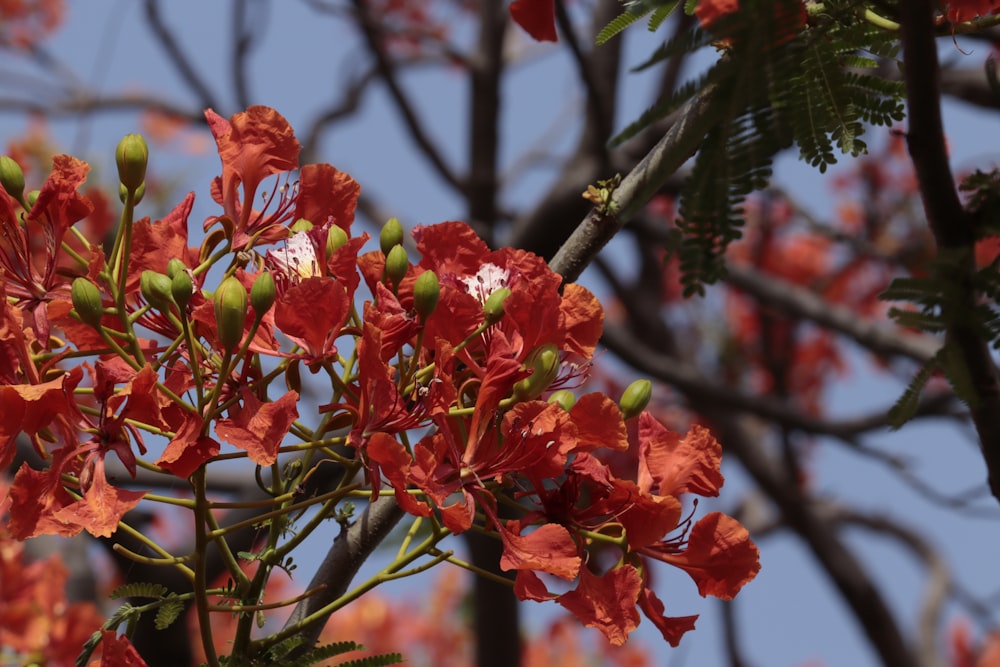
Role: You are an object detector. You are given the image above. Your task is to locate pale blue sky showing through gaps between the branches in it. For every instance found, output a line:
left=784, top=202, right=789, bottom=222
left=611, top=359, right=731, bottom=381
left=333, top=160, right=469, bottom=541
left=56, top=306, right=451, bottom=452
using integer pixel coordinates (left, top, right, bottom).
left=0, top=0, right=1000, bottom=667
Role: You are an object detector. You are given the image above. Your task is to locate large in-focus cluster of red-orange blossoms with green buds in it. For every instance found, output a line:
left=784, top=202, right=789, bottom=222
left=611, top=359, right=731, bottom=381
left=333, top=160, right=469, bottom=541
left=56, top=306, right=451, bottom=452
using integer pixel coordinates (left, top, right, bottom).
left=0, top=107, right=759, bottom=664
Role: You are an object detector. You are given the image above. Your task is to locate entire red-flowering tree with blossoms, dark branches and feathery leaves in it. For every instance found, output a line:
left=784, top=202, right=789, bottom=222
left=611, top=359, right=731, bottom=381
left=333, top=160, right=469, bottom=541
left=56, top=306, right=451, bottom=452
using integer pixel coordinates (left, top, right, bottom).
left=0, top=0, right=1000, bottom=665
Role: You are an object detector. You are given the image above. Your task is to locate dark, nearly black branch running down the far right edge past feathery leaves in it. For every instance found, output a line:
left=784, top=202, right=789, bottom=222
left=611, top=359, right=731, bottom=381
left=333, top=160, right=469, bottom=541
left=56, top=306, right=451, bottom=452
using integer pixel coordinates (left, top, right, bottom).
left=899, top=0, right=1000, bottom=500
